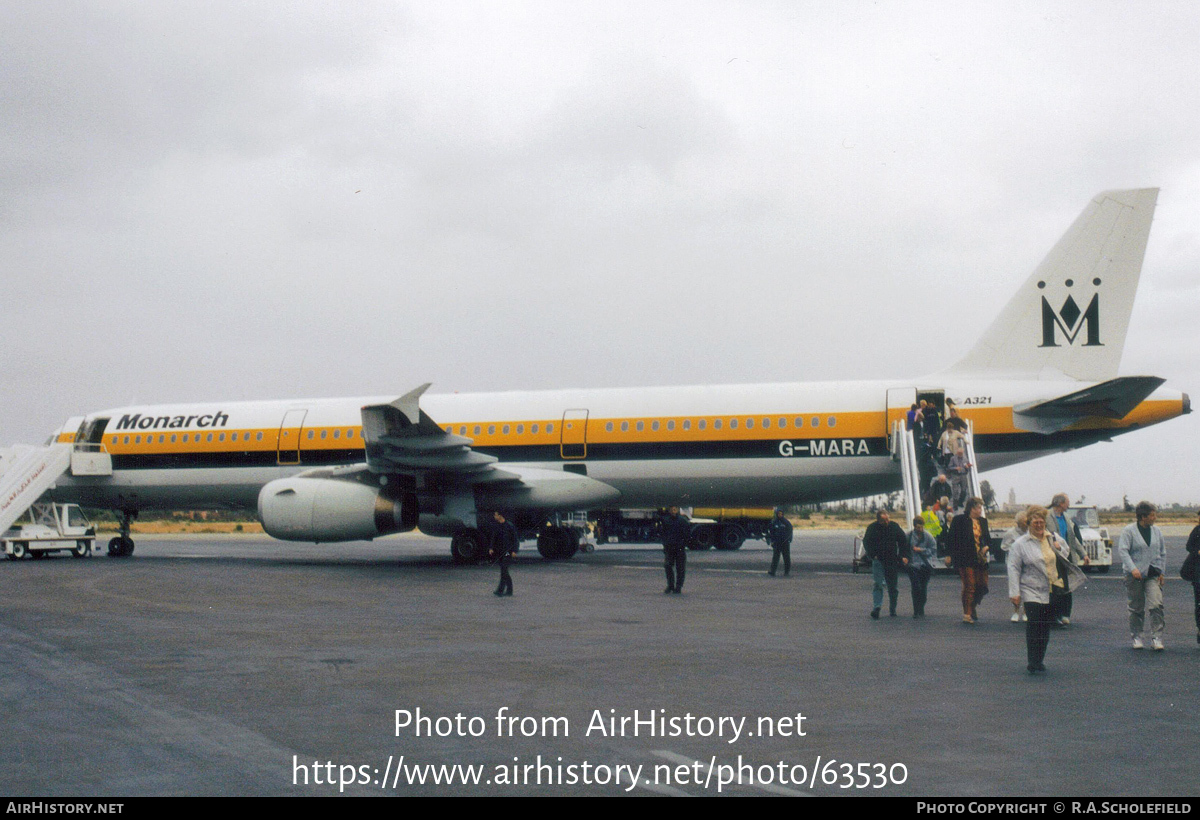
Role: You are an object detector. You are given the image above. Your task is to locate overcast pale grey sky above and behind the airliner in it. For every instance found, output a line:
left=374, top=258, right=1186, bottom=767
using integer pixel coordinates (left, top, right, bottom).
left=0, top=0, right=1200, bottom=503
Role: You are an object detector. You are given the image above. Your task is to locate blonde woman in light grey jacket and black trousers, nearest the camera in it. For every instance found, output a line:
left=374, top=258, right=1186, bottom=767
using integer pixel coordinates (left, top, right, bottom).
left=1006, top=507, right=1086, bottom=675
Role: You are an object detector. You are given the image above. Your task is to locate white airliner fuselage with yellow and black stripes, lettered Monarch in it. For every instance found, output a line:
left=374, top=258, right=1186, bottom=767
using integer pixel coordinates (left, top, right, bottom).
left=55, top=378, right=1188, bottom=509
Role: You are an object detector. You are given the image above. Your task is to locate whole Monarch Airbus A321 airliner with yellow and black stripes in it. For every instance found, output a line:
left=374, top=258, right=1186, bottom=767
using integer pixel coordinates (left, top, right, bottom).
left=37, top=188, right=1190, bottom=559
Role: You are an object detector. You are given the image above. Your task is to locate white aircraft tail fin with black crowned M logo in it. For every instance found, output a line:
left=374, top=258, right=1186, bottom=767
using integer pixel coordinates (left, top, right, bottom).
left=949, top=188, right=1158, bottom=382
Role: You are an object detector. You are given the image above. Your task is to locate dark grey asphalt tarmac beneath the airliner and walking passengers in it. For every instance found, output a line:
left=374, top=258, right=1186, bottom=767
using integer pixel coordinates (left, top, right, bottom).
left=0, top=532, right=1200, bottom=797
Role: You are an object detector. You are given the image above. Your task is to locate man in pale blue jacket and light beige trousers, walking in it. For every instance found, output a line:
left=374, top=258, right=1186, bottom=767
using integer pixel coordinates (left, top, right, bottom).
left=1117, top=501, right=1166, bottom=652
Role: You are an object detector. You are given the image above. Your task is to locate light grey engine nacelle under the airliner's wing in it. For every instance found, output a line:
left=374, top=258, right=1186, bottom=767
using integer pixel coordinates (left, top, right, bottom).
left=258, top=478, right=419, bottom=543
